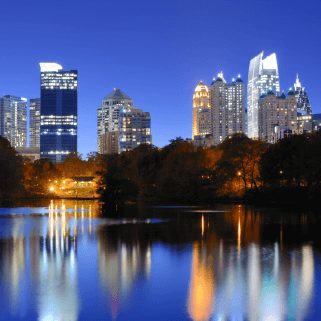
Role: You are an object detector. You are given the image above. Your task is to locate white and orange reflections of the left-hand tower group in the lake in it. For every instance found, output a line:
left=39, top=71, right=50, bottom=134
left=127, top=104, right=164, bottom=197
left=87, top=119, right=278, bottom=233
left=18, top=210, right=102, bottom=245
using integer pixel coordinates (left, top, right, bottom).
left=0, top=201, right=99, bottom=321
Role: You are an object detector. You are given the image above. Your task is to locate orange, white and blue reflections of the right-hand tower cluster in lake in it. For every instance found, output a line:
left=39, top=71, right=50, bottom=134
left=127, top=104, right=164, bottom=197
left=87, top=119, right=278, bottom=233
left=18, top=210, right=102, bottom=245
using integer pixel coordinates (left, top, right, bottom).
left=187, top=211, right=314, bottom=321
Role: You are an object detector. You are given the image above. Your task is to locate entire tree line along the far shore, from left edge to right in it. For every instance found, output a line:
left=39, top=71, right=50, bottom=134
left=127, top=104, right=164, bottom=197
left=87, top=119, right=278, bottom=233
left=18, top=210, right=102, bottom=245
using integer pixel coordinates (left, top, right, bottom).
left=0, top=132, right=321, bottom=206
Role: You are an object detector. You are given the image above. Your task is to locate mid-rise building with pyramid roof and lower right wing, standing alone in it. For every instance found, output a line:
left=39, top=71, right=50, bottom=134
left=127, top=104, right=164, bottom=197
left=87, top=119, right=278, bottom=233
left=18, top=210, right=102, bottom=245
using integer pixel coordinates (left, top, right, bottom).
left=97, top=88, right=151, bottom=154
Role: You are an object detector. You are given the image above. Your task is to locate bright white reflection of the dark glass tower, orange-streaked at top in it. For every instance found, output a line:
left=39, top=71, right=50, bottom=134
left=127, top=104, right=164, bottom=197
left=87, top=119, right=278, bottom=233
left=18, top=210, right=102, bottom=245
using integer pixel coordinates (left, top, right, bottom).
left=36, top=202, right=79, bottom=321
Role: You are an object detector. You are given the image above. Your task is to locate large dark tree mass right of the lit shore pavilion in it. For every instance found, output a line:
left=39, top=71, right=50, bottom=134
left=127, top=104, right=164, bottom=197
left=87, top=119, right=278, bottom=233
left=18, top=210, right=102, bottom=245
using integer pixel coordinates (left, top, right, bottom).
left=102, top=132, right=321, bottom=205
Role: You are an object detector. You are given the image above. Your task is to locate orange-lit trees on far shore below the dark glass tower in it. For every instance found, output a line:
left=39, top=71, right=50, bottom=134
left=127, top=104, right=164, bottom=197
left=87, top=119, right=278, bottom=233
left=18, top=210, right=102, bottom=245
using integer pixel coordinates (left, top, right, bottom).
left=0, top=136, right=104, bottom=200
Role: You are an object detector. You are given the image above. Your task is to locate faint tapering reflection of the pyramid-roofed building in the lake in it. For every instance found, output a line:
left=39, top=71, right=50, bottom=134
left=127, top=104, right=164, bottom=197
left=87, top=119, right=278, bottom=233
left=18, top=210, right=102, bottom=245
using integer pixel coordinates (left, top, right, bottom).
left=98, top=224, right=152, bottom=320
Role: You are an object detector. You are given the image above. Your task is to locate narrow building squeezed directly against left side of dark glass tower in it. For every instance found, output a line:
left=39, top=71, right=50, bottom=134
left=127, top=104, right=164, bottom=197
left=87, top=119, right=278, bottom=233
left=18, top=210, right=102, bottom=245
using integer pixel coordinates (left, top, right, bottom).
left=29, top=98, right=40, bottom=148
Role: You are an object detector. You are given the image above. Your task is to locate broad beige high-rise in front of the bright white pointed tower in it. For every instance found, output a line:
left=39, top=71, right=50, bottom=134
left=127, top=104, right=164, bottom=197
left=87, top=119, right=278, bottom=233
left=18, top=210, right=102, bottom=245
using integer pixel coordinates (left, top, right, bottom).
left=258, top=91, right=298, bottom=143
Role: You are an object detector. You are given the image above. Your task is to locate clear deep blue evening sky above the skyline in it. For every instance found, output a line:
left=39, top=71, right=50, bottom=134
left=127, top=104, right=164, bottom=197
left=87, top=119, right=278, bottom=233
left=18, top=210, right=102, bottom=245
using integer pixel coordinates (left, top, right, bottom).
left=0, top=0, right=321, bottom=154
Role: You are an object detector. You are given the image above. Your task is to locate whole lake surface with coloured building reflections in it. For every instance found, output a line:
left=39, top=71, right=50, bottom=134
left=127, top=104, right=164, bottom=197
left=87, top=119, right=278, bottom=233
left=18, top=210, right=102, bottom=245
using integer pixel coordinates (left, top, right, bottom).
left=0, top=201, right=321, bottom=321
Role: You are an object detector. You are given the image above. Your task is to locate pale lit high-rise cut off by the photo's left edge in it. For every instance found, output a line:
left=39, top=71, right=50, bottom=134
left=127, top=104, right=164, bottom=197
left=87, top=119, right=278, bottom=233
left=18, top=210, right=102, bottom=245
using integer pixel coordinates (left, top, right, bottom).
left=0, top=95, right=27, bottom=148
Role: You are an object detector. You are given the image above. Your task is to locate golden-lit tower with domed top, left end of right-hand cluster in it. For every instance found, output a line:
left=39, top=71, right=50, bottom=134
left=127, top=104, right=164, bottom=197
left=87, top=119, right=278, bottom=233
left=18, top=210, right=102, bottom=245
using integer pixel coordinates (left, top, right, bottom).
left=192, top=81, right=212, bottom=139
